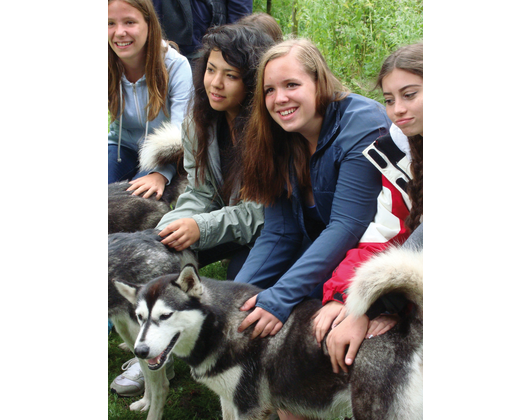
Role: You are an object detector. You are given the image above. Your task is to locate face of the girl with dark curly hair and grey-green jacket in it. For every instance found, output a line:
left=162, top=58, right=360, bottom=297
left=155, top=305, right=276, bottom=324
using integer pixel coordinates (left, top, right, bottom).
left=204, top=50, right=246, bottom=122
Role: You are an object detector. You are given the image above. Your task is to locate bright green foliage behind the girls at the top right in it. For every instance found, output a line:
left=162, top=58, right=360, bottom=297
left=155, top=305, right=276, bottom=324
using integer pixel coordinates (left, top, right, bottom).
left=254, top=0, right=423, bottom=100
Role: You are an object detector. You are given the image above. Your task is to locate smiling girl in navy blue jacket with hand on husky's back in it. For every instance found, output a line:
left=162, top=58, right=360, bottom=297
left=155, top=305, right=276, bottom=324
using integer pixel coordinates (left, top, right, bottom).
left=236, top=40, right=391, bottom=337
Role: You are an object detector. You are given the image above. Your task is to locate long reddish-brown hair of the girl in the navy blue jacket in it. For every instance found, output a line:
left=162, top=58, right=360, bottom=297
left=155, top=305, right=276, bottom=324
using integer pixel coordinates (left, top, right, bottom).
left=241, top=39, right=349, bottom=205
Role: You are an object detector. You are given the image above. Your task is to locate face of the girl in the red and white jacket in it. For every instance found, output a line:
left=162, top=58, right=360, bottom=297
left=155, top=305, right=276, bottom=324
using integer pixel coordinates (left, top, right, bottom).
left=383, top=69, right=423, bottom=137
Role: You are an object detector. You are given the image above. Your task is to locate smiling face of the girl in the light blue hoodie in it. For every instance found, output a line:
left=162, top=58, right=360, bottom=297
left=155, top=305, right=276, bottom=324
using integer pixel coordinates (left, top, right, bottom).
left=108, top=0, right=149, bottom=67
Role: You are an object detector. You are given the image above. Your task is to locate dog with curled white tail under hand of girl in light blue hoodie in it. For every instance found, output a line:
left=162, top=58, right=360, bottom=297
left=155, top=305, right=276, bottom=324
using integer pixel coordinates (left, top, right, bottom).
left=108, top=123, right=188, bottom=234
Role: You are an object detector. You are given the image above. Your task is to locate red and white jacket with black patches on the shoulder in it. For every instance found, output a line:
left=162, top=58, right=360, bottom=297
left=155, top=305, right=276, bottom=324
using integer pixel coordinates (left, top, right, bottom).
left=323, top=126, right=412, bottom=305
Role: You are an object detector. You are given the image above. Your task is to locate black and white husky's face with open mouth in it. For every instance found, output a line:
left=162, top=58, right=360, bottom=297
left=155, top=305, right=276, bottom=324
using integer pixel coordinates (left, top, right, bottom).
left=115, top=266, right=206, bottom=370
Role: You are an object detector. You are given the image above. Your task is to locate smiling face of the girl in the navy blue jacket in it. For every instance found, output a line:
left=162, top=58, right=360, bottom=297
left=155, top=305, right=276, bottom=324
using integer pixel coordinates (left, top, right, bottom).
left=264, top=50, right=324, bottom=146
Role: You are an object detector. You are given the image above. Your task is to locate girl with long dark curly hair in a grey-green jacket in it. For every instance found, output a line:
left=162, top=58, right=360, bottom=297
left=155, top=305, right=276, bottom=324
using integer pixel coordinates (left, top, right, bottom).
left=157, top=24, right=273, bottom=280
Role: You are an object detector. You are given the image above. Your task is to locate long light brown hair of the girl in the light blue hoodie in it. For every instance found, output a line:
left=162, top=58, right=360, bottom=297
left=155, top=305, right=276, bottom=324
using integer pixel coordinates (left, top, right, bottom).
left=107, top=0, right=178, bottom=121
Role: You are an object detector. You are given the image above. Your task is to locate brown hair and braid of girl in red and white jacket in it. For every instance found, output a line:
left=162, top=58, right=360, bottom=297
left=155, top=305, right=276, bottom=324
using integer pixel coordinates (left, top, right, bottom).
left=377, top=43, right=423, bottom=232
